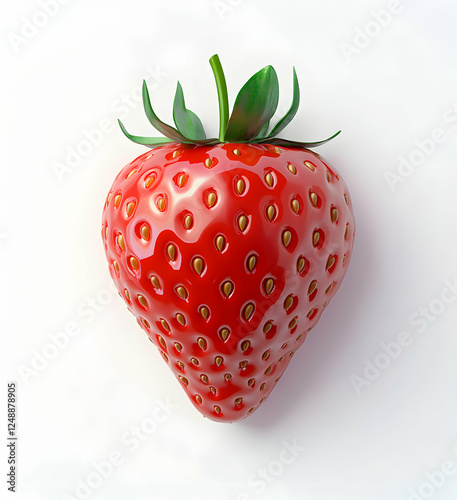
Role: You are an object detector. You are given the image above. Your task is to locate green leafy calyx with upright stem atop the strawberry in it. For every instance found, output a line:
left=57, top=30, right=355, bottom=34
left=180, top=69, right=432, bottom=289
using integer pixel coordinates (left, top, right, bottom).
left=118, top=54, right=341, bottom=149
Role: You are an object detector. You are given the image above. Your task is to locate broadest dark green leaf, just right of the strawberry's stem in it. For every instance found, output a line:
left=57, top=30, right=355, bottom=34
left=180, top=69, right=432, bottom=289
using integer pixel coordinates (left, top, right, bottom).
left=225, top=66, right=279, bottom=142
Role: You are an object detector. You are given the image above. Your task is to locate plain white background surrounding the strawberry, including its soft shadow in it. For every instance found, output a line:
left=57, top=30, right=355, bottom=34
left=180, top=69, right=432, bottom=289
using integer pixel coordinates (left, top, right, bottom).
left=0, top=0, right=457, bottom=500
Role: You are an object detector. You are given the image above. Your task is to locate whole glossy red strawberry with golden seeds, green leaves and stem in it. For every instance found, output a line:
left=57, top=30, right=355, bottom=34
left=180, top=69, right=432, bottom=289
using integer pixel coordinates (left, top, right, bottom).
left=102, top=56, right=355, bottom=422
